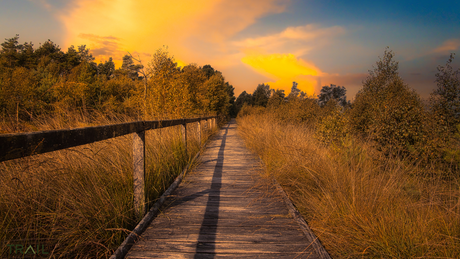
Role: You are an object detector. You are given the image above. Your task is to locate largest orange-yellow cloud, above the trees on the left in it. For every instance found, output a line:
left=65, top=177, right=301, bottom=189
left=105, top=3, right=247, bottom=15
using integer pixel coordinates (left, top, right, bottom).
left=57, top=0, right=288, bottom=66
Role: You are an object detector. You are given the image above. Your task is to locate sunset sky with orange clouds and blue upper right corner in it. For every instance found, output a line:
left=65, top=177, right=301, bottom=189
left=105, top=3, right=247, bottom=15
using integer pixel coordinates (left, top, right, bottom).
left=0, top=0, right=460, bottom=99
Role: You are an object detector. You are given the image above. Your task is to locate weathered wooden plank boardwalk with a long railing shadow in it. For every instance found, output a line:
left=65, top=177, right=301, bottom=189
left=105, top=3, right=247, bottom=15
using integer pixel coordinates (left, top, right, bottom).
left=126, top=120, right=328, bottom=258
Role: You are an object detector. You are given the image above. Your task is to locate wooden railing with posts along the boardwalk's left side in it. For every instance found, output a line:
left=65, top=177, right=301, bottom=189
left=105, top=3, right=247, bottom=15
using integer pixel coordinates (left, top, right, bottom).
left=0, top=116, right=216, bottom=219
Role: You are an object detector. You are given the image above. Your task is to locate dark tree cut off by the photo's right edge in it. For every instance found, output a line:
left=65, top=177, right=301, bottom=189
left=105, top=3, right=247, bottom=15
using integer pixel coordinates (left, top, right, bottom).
left=430, top=53, right=460, bottom=132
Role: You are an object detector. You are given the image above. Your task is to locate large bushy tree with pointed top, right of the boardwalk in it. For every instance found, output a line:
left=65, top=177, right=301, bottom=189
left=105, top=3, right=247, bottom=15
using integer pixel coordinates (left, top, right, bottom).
left=350, top=49, right=424, bottom=154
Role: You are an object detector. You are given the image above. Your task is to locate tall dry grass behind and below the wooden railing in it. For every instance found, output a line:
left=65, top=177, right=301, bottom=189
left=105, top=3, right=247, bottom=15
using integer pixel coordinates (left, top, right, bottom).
left=0, top=111, right=217, bottom=258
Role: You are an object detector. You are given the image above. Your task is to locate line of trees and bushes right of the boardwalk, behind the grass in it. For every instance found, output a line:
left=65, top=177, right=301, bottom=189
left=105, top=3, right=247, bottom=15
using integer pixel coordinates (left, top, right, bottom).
left=235, top=48, right=460, bottom=171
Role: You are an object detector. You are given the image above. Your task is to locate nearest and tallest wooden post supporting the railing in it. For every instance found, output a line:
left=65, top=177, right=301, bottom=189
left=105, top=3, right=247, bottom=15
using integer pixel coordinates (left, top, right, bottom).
left=133, top=131, right=146, bottom=221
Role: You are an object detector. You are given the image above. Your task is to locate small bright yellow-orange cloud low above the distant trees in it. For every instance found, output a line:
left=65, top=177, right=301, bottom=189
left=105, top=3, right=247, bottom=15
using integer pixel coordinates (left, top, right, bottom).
left=241, top=54, right=323, bottom=95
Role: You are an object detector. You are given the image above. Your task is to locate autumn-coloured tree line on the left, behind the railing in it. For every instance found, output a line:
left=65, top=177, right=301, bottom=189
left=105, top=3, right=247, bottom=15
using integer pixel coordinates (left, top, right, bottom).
left=0, top=35, right=235, bottom=132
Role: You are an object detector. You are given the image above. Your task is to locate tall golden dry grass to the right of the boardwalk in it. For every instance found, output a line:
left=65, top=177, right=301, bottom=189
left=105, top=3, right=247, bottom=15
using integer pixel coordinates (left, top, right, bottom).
left=237, top=112, right=460, bottom=258
